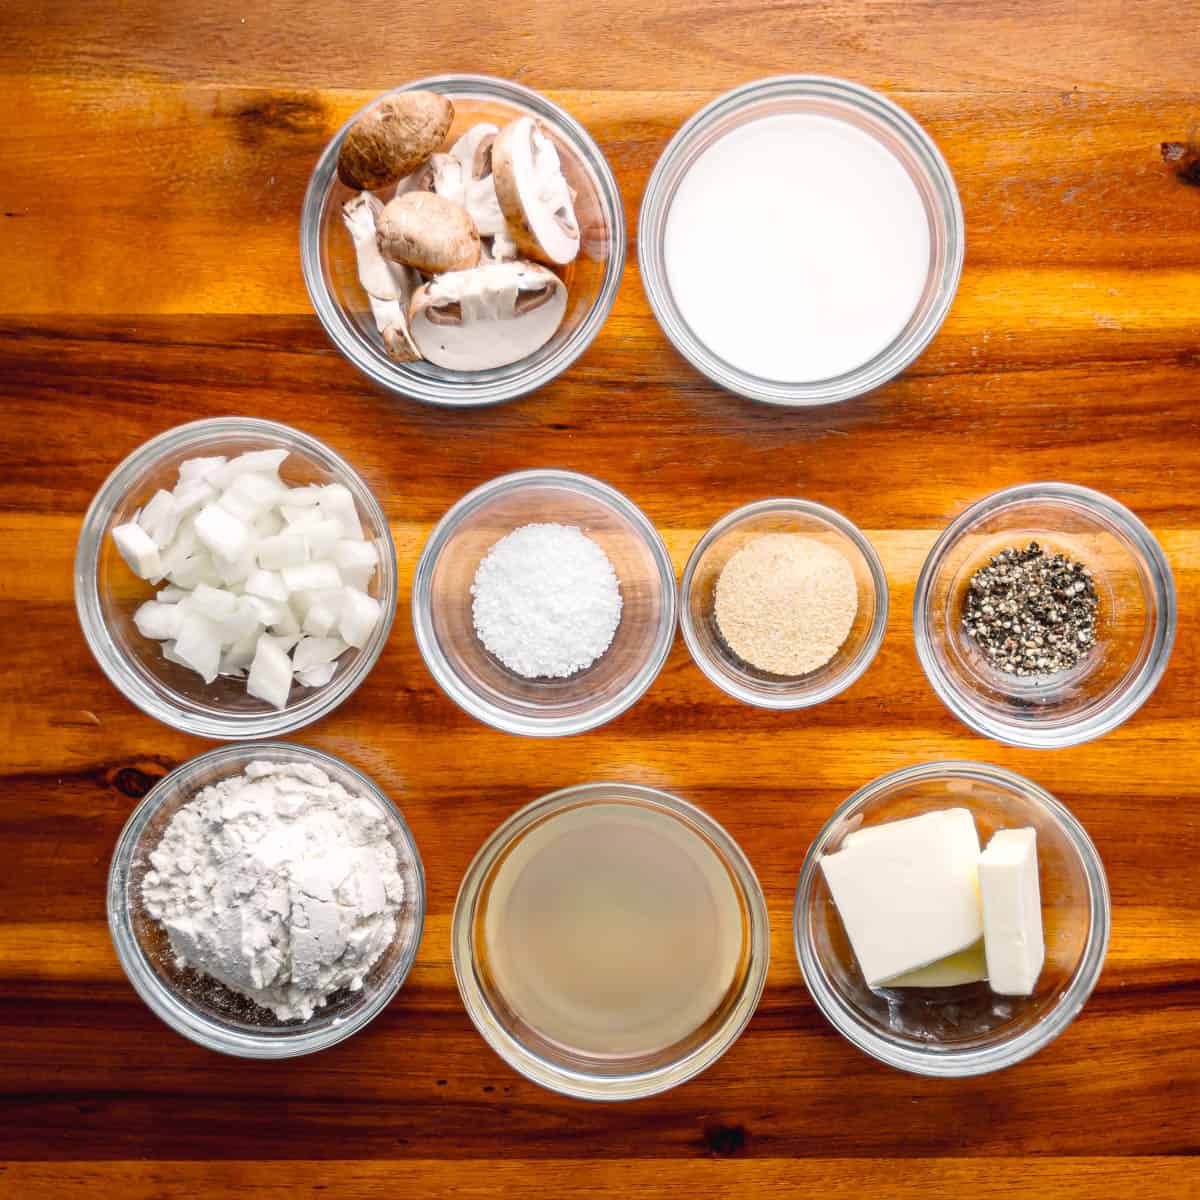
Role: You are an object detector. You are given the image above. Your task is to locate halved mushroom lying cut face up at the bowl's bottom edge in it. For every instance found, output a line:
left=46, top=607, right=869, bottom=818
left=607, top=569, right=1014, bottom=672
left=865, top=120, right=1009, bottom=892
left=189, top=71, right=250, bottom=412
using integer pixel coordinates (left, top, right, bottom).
left=409, top=260, right=566, bottom=371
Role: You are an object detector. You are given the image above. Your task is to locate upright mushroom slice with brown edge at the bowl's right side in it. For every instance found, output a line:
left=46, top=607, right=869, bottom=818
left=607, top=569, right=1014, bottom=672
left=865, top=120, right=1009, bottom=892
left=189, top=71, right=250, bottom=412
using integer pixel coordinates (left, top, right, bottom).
left=491, top=116, right=580, bottom=265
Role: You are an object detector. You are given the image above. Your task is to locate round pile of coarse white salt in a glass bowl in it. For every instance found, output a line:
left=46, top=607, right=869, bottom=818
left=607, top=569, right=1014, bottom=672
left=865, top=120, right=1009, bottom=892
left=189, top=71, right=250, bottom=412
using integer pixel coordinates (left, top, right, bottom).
left=470, top=523, right=622, bottom=679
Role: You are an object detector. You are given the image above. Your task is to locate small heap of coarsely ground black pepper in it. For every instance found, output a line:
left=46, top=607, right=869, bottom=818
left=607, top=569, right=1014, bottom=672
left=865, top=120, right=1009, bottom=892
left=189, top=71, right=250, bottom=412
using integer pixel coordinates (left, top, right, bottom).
left=962, top=541, right=1099, bottom=676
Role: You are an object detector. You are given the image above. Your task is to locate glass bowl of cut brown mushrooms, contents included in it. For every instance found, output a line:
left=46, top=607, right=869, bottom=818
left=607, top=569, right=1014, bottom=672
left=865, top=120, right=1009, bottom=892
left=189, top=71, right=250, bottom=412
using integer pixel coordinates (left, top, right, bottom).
left=300, top=76, right=625, bottom=407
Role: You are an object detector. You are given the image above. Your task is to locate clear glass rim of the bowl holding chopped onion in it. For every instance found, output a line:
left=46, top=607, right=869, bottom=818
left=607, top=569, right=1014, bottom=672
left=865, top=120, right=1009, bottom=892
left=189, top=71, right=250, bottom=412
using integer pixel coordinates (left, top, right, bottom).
left=74, top=416, right=398, bottom=742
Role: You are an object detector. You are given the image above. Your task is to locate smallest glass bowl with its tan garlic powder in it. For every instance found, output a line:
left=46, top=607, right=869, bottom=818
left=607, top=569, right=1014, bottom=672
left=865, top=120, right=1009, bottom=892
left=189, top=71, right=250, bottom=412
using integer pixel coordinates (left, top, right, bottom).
left=679, top=499, right=888, bottom=709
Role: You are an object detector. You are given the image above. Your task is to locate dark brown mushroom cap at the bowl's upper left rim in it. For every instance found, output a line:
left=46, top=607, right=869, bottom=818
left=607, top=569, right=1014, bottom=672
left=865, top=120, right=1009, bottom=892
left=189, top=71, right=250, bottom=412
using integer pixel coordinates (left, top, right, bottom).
left=337, top=91, right=454, bottom=191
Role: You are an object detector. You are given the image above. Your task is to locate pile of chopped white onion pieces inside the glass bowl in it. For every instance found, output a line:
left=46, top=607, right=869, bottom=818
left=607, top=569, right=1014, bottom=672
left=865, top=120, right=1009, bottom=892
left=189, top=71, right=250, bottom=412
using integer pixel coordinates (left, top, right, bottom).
left=113, top=450, right=382, bottom=708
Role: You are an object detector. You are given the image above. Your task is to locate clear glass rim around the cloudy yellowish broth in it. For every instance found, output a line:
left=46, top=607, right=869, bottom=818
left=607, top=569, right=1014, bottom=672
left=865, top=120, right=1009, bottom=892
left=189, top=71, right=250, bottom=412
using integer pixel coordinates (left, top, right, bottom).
left=451, top=782, right=770, bottom=1100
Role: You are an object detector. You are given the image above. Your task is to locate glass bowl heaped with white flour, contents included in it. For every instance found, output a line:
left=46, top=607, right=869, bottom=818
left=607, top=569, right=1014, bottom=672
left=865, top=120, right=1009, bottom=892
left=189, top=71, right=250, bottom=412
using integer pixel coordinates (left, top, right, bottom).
left=108, top=743, right=425, bottom=1058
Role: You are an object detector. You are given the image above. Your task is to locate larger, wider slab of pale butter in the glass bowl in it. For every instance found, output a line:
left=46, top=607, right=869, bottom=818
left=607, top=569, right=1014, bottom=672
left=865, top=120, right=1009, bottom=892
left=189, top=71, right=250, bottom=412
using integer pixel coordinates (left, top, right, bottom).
left=821, top=809, right=983, bottom=988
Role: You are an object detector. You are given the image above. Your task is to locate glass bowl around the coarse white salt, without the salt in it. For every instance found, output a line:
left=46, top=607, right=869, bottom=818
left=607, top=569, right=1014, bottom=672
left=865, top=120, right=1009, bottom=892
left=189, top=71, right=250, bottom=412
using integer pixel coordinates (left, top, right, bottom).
left=413, top=470, right=676, bottom=737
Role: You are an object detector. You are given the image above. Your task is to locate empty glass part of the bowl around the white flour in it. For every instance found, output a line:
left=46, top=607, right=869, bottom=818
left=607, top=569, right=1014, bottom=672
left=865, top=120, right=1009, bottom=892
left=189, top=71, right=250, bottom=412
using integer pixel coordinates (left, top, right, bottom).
left=108, top=743, right=425, bottom=1058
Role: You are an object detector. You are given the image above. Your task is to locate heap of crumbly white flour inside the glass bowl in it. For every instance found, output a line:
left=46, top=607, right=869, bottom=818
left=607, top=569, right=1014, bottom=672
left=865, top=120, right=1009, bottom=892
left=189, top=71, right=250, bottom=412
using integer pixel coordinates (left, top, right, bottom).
left=142, top=762, right=404, bottom=1021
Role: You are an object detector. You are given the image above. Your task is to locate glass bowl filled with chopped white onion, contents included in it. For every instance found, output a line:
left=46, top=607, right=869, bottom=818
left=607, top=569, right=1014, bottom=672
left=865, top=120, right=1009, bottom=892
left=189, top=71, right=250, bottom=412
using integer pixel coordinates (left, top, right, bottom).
left=74, top=418, right=397, bottom=740
